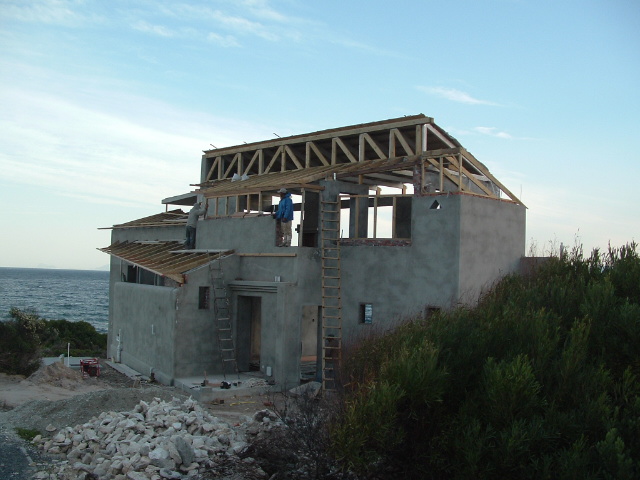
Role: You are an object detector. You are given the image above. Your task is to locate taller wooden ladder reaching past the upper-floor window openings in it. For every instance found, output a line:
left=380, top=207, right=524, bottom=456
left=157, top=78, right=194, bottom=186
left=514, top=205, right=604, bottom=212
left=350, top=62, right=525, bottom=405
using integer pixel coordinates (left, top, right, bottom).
left=320, top=196, right=342, bottom=390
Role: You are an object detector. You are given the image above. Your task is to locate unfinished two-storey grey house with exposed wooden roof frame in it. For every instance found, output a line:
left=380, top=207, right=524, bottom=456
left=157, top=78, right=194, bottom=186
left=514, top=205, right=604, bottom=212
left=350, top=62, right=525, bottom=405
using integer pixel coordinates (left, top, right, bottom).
left=101, top=115, right=525, bottom=388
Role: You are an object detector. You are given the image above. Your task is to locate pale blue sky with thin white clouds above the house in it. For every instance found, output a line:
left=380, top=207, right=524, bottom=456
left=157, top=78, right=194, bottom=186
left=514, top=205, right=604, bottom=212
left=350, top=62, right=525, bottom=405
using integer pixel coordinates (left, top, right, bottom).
left=0, top=0, right=640, bottom=269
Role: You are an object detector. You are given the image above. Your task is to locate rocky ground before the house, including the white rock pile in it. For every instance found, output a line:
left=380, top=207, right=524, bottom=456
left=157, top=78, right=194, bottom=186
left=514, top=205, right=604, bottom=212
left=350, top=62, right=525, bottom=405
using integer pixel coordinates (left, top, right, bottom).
left=0, top=364, right=286, bottom=480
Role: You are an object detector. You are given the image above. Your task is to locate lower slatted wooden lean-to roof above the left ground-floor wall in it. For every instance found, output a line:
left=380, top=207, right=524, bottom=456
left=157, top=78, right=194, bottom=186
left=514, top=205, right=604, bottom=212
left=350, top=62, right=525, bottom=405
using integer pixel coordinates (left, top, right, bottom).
left=98, top=241, right=233, bottom=284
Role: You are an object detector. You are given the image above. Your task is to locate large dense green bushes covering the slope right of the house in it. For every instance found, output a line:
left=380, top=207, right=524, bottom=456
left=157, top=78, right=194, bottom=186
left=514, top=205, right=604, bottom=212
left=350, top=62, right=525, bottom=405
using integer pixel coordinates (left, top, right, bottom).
left=330, top=243, right=640, bottom=479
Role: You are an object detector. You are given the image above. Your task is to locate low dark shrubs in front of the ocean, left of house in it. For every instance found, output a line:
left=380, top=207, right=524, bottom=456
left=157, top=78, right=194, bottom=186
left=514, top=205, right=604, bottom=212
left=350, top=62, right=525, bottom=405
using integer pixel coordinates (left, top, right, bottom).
left=0, top=308, right=107, bottom=375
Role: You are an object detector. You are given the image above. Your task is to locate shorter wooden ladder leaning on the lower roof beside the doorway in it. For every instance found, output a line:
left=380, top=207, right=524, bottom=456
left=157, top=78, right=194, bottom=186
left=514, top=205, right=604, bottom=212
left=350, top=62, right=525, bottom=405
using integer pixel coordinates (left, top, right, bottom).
left=209, top=256, right=240, bottom=380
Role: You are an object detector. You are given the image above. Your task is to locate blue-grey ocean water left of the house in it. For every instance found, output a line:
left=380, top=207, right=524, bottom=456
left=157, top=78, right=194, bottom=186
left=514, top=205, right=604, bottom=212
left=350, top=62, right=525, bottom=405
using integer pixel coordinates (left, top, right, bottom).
left=0, top=267, right=109, bottom=333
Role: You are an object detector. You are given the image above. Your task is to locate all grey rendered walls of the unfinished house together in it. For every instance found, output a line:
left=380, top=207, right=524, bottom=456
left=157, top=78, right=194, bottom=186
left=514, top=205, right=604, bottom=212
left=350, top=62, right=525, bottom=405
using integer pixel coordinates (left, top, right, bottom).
left=104, top=186, right=525, bottom=385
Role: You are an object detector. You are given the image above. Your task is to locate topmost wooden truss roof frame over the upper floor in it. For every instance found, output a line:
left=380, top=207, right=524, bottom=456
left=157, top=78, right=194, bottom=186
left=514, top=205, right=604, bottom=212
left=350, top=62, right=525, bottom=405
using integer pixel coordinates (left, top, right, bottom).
left=197, top=114, right=521, bottom=203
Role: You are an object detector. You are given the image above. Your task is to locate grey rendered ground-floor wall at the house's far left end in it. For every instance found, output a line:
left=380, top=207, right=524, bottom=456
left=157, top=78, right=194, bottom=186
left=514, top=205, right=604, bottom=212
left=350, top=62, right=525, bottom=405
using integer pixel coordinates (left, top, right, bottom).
left=109, top=282, right=178, bottom=383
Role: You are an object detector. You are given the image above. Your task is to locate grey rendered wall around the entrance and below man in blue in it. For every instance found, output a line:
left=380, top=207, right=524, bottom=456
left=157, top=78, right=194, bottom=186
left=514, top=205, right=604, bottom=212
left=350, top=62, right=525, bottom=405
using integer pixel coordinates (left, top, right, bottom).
left=196, top=215, right=320, bottom=385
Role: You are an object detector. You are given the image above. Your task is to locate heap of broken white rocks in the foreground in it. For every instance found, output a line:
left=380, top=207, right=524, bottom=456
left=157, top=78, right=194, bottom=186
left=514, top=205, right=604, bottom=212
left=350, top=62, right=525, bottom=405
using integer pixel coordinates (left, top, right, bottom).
left=33, top=398, right=278, bottom=480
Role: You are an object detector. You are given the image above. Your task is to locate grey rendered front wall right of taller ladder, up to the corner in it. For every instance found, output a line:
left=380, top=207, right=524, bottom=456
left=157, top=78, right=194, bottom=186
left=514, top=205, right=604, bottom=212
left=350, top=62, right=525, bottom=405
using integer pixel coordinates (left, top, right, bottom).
left=341, top=196, right=460, bottom=340
